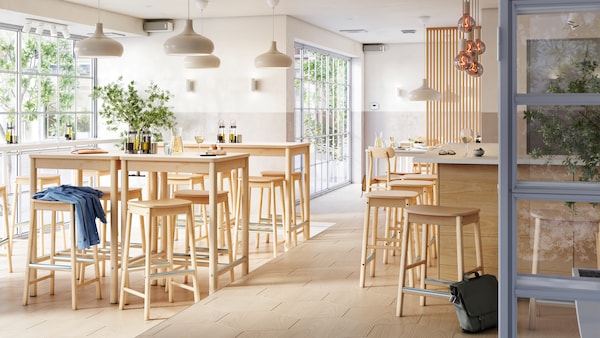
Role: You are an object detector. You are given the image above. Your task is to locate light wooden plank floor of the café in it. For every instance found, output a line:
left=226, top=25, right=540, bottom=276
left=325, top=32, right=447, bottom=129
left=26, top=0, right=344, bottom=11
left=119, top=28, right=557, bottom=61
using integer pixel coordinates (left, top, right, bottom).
left=0, top=185, right=579, bottom=337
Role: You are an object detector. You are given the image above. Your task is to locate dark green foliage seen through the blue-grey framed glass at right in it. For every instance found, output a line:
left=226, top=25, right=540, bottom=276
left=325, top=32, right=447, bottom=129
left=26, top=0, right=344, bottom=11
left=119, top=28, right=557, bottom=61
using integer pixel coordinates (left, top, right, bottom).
left=524, top=51, right=600, bottom=181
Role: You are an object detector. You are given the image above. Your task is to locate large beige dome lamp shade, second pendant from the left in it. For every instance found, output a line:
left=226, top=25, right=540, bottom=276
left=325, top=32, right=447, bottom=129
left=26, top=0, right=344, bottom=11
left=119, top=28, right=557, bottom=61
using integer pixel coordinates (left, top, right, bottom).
left=164, top=19, right=215, bottom=55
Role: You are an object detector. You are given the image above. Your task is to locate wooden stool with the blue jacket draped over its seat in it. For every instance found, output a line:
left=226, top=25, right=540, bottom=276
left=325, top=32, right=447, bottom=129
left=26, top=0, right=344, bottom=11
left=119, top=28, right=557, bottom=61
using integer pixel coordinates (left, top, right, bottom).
left=23, top=199, right=102, bottom=310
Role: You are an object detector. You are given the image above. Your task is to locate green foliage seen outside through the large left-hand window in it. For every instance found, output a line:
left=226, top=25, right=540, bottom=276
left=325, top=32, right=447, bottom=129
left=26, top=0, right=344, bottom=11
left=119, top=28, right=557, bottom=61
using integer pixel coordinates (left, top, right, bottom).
left=0, top=30, right=90, bottom=138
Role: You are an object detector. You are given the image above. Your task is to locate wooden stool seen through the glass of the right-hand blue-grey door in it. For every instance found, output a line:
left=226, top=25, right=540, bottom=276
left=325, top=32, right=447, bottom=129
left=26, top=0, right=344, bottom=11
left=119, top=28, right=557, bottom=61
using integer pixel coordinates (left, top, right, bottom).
left=529, top=209, right=600, bottom=330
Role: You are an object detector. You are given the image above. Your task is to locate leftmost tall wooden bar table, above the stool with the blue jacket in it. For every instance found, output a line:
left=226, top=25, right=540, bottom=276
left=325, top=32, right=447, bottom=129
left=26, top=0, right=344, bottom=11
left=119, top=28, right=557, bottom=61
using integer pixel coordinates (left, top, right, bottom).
left=28, top=151, right=120, bottom=304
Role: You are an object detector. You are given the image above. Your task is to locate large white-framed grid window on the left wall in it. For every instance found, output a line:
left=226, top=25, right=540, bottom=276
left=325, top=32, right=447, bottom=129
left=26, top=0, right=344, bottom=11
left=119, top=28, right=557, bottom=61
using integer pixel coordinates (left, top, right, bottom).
left=0, top=27, right=95, bottom=143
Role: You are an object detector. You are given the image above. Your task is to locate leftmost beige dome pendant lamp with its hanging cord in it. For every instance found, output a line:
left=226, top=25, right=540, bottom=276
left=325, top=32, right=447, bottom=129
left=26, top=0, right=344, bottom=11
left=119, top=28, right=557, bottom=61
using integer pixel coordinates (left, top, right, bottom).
left=75, top=0, right=123, bottom=58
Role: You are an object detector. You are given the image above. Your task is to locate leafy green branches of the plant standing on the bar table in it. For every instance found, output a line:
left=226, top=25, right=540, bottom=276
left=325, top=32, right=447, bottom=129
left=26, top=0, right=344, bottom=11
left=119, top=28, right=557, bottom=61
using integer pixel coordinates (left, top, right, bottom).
left=92, top=76, right=177, bottom=146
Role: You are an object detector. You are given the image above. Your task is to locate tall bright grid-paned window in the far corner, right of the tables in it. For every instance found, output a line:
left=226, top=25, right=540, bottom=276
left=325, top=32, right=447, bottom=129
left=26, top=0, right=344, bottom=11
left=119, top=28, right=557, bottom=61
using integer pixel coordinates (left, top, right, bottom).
left=294, top=44, right=351, bottom=196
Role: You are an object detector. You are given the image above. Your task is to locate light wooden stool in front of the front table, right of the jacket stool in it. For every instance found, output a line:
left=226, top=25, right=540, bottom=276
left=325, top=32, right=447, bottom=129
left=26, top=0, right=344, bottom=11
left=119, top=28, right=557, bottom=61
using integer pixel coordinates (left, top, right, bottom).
left=119, top=199, right=200, bottom=320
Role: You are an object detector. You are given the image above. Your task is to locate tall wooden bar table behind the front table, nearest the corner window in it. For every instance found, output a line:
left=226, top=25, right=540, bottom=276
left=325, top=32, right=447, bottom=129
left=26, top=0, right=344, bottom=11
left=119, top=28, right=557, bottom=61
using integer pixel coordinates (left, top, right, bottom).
left=185, top=142, right=311, bottom=250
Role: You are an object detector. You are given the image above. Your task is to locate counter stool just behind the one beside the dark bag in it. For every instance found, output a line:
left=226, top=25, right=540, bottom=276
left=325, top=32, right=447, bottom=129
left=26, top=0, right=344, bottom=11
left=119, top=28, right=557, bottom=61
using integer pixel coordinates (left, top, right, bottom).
left=359, top=190, right=418, bottom=288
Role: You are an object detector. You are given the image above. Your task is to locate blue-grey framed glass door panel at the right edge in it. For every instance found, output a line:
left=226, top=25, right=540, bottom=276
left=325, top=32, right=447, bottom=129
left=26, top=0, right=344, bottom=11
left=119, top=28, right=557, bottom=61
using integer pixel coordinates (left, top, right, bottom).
left=499, top=0, right=600, bottom=337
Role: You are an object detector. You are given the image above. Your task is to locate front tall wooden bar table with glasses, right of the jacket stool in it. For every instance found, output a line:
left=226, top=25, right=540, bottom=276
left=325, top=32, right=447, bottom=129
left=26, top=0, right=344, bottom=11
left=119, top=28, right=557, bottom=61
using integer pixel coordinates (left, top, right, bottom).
left=120, top=152, right=249, bottom=294
